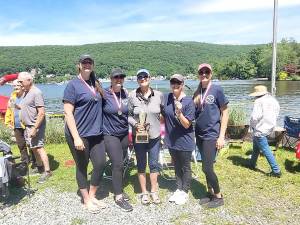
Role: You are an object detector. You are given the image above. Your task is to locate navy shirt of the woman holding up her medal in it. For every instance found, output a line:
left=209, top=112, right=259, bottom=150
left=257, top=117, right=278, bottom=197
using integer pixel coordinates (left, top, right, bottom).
left=163, top=93, right=195, bottom=151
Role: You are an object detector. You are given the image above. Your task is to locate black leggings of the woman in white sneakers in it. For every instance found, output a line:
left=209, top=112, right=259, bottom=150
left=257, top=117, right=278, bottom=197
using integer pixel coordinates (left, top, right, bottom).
left=170, top=149, right=192, bottom=193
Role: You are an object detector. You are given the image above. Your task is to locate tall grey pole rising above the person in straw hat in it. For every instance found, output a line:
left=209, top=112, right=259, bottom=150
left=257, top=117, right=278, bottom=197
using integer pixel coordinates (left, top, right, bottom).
left=271, top=0, right=278, bottom=96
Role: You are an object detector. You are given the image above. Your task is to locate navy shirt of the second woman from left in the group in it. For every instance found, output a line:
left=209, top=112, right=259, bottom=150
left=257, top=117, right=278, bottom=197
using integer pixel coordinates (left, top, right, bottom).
left=103, top=88, right=128, bottom=136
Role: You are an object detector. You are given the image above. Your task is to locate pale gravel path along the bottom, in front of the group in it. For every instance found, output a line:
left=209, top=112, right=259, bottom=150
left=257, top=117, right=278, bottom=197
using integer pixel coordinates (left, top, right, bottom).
left=0, top=188, right=299, bottom=225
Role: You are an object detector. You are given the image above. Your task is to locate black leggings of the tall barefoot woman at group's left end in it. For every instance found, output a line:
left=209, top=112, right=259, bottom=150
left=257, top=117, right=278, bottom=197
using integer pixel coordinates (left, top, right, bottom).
left=66, top=135, right=106, bottom=189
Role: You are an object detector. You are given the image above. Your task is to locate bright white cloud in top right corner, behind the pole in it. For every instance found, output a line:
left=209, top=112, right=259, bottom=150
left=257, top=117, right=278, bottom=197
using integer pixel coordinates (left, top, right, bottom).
left=184, top=0, right=300, bottom=14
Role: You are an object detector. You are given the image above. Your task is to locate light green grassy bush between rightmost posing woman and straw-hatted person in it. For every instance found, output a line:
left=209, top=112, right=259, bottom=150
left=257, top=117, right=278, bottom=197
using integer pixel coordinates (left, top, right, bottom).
left=228, top=105, right=247, bottom=126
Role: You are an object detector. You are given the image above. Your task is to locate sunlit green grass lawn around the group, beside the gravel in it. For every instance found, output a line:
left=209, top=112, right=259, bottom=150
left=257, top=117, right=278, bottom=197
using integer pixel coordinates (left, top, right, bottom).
left=5, top=143, right=300, bottom=224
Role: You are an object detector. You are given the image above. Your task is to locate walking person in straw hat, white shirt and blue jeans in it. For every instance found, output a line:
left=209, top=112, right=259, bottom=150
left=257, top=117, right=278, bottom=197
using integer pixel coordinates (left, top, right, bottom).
left=249, top=85, right=281, bottom=177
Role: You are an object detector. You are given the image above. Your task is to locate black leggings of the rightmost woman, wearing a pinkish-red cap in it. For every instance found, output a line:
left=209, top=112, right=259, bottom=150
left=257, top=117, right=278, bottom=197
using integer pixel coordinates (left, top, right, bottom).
left=197, top=138, right=220, bottom=194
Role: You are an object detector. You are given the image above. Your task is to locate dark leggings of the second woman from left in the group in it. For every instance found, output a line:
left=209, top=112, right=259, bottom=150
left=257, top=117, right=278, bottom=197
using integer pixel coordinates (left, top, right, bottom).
left=104, top=134, right=128, bottom=195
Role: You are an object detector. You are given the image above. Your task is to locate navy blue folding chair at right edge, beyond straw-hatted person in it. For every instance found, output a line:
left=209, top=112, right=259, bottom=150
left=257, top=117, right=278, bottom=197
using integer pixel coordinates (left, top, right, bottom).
left=283, top=116, right=300, bottom=148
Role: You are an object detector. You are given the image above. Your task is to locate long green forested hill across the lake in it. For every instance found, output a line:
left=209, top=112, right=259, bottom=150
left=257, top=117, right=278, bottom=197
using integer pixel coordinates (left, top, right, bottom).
left=0, top=41, right=265, bottom=77
